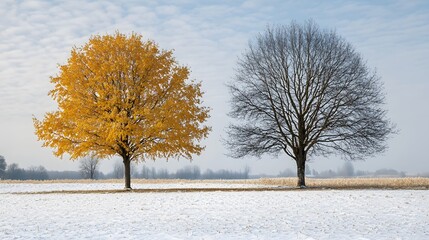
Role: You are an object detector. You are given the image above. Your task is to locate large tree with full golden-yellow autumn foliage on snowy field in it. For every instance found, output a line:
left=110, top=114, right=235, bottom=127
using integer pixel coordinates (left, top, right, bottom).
left=33, top=32, right=210, bottom=189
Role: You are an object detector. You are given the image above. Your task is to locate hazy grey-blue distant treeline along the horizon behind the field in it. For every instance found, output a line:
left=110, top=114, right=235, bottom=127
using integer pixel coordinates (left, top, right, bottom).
left=0, top=155, right=429, bottom=180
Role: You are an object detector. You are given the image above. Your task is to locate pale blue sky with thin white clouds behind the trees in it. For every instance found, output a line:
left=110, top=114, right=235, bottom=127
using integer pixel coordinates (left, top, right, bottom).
left=0, top=0, right=429, bottom=174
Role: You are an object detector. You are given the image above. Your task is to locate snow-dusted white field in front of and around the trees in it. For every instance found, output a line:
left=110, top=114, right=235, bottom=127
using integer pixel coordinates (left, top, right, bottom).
left=0, top=183, right=429, bottom=239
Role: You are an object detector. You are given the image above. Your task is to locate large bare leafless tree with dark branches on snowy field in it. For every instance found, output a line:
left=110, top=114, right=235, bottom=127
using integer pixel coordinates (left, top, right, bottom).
left=227, top=21, right=395, bottom=187
